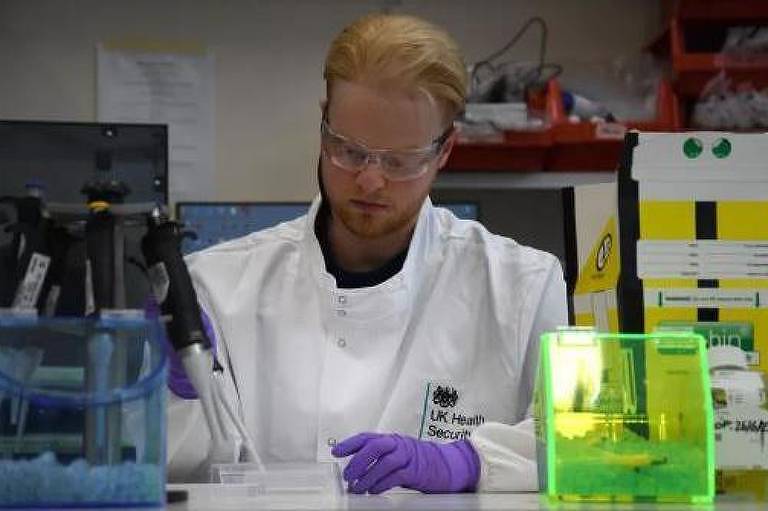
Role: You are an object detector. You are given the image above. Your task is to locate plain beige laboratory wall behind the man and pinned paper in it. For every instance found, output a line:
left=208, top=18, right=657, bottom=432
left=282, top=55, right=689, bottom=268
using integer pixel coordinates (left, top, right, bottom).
left=0, top=0, right=662, bottom=204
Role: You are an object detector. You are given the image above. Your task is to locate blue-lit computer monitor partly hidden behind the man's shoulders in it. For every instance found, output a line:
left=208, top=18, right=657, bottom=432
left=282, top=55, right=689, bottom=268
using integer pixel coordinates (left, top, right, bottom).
left=176, top=201, right=479, bottom=254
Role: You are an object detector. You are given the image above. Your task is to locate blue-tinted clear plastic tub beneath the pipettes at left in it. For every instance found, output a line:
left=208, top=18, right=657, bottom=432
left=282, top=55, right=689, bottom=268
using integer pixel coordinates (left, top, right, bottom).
left=0, top=314, right=166, bottom=507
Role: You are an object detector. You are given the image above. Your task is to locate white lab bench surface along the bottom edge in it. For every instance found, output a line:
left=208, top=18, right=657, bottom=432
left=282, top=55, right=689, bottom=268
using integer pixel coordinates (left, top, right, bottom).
left=166, top=484, right=766, bottom=511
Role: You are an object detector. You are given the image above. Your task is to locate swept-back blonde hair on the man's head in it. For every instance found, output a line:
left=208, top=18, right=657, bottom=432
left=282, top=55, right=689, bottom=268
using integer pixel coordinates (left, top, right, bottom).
left=323, top=14, right=468, bottom=120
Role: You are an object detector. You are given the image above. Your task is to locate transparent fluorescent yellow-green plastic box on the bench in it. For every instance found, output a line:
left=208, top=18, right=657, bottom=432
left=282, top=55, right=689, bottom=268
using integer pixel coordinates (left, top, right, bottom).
left=535, top=329, right=715, bottom=503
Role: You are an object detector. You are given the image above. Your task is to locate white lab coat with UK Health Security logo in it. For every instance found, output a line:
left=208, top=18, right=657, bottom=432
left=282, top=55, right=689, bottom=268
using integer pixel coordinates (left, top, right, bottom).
left=168, top=198, right=567, bottom=490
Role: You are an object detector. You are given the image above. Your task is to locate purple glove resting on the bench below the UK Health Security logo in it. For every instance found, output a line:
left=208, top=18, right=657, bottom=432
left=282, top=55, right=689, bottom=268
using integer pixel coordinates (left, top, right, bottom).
left=331, top=433, right=480, bottom=493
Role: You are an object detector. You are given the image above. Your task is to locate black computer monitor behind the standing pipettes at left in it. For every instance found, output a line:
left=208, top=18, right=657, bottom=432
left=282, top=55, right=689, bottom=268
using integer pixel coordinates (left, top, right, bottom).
left=0, top=120, right=168, bottom=315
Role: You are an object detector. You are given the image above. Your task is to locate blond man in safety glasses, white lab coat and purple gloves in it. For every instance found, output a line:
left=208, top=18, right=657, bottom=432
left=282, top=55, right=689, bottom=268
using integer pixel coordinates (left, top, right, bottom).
left=169, top=15, right=567, bottom=493
